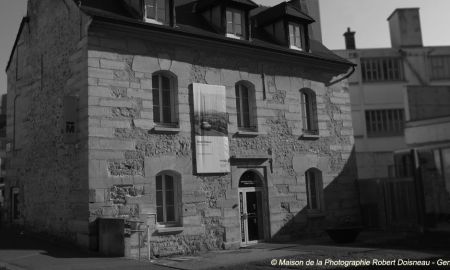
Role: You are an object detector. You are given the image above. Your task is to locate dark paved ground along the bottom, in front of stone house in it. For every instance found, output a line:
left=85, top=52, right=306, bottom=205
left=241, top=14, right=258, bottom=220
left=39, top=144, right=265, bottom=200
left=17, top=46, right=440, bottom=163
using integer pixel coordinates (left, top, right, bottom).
left=0, top=228, right=450, bottom=270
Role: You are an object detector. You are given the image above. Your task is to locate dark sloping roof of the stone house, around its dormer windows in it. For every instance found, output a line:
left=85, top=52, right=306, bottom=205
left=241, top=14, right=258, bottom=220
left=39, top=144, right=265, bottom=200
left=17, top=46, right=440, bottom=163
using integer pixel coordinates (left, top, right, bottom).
left=7, top=0, right=355, bottom=69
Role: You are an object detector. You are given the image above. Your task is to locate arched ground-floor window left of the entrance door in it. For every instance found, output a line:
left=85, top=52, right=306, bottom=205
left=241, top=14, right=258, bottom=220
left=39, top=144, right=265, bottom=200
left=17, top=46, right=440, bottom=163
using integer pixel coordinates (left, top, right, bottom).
left=156, top=173, right=180, bottom=226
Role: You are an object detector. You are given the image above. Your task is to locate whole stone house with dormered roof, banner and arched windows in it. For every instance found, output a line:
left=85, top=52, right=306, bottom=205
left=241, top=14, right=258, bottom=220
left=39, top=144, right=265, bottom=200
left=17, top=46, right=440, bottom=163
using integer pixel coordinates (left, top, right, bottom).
left=6, top=0, right=359, bottom=256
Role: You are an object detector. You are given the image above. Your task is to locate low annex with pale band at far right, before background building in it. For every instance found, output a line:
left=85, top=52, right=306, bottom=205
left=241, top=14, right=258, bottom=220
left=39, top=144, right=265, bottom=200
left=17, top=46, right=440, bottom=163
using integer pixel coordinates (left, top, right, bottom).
left=394, top=86, right=450, bottom=231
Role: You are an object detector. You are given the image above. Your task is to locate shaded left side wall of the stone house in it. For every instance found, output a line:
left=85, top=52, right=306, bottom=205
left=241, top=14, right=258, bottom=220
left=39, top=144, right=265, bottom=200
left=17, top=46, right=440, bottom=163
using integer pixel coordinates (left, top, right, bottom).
left=6, top=0, right=89, bottom=246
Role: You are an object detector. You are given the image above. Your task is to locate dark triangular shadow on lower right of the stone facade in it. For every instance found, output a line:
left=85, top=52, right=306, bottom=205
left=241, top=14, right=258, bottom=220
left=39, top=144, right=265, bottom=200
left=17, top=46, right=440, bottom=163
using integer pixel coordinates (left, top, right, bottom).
left=272, top=148, right=361, bottom=241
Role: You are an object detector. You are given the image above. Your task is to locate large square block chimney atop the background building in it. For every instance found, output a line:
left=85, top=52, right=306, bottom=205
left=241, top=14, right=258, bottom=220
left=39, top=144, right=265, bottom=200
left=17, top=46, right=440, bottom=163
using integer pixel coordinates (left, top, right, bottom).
left=388, top=8, right=423, bottom=48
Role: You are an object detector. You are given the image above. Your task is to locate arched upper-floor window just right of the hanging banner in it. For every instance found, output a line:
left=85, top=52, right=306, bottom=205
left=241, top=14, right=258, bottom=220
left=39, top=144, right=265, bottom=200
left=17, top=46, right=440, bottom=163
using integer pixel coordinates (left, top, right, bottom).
left=236, top=83, right=256, bottom=130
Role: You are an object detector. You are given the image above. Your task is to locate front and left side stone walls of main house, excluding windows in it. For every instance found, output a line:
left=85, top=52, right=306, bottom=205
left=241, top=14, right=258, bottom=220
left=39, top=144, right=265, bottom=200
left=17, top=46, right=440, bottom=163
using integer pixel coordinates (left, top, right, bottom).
left=8, top=0, right=359, bottom=256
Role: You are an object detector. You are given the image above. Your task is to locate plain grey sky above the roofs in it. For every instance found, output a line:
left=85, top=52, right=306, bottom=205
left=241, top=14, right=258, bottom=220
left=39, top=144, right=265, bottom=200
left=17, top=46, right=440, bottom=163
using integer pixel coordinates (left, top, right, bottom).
left=0, top=0, right=450, bottom=93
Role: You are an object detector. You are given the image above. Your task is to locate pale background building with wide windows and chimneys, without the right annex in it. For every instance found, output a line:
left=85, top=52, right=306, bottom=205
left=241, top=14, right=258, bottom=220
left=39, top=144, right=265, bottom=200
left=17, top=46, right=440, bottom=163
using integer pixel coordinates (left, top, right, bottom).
left=335, top=8, right=450, bottom=179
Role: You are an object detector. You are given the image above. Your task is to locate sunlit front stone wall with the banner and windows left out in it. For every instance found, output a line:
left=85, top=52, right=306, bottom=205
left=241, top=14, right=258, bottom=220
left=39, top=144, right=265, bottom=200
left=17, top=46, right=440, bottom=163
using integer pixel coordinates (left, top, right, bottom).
left=88, top=23, right=359, bottom=256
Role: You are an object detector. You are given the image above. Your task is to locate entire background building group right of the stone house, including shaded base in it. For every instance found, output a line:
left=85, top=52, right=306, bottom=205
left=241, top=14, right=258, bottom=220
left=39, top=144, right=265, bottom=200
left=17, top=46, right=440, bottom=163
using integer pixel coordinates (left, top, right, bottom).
left=336, top=8, right=450, bottom=229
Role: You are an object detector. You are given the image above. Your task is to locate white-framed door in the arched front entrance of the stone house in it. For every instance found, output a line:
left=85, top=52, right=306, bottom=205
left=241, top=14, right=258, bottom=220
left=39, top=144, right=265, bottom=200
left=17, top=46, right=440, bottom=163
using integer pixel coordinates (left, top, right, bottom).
left=239, top=187, right=264, bottom=246
